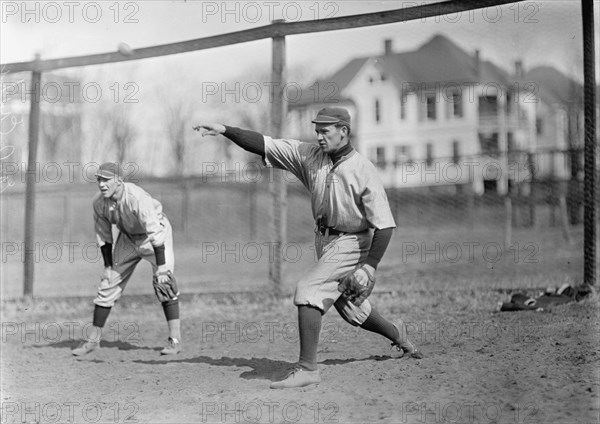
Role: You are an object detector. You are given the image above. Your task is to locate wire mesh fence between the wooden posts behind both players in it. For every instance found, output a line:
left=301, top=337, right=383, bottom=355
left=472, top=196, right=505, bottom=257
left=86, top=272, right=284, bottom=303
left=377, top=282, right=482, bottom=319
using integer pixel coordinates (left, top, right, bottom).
left=1, top=1, right=597, bottom=296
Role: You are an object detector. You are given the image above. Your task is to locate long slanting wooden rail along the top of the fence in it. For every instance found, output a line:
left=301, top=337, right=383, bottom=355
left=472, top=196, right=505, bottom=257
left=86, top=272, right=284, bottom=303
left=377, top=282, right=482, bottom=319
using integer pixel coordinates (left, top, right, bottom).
left=0, top=0, right=524, bottom=72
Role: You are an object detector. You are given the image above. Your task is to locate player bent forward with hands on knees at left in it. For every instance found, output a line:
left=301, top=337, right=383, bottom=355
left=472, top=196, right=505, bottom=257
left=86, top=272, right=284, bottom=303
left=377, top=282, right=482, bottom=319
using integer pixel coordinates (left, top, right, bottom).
left=72, top=163, right=181, bottom=356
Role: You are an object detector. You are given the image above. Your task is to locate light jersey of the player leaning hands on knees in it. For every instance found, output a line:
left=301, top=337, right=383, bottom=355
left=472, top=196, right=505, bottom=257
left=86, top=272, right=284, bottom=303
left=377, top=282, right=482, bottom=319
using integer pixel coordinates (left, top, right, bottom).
left=93, top=183, right=166, bottom=246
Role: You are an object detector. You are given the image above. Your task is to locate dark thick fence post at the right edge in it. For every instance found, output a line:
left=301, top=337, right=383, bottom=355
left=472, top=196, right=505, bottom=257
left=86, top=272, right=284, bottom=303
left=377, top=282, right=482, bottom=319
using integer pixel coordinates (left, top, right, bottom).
left=581, top=0, right=597, bottom=285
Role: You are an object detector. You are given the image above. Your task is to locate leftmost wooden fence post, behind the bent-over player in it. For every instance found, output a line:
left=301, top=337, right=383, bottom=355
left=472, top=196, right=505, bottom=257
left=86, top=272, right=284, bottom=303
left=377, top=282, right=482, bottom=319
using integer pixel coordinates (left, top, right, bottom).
left=23, top=54, right=42, bottom=297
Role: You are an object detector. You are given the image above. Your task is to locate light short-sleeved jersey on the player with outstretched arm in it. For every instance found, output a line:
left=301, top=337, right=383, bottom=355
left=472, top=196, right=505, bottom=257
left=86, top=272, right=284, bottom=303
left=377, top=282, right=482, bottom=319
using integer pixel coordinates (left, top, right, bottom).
left=264, top=136, right=396, bottom=233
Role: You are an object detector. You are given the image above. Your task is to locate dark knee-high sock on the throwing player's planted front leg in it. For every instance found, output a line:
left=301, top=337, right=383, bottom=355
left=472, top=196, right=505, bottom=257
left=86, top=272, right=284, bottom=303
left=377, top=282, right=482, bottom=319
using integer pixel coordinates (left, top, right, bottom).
left=298, top=305, right=323, bottom=371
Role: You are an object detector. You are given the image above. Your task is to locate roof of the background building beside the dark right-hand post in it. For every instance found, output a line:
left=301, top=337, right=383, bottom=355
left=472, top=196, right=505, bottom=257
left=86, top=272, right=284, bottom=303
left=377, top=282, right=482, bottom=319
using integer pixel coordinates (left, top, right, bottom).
left=523, top=66, right=583, bottom=107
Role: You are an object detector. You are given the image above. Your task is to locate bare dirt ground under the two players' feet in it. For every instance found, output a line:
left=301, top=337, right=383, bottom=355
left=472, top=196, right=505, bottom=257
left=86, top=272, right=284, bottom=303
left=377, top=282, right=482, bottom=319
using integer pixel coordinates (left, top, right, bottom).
left=1, top=284, right=600, bottom=424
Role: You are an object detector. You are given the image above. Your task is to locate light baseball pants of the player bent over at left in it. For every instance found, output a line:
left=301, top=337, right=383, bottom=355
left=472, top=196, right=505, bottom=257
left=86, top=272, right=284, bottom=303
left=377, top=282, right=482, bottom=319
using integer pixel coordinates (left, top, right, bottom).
left=94, top=216, right=175, bottom=308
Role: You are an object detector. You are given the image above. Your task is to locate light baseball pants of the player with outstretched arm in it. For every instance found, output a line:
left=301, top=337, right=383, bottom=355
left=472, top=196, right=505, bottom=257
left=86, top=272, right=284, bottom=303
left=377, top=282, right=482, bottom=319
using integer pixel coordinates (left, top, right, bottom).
left=294, top=230, right=372, bottom=326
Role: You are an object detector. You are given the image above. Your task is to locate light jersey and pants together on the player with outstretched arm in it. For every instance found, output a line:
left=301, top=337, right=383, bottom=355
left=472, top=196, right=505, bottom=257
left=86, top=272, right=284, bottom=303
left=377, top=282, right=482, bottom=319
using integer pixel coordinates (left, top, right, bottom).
left=264, top=136, right=396, bottom=325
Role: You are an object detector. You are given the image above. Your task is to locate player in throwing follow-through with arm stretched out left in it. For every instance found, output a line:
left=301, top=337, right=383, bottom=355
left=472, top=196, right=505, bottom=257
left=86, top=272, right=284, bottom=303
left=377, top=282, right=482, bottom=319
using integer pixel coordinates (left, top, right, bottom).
left=194, top=108, right=422, bottom=388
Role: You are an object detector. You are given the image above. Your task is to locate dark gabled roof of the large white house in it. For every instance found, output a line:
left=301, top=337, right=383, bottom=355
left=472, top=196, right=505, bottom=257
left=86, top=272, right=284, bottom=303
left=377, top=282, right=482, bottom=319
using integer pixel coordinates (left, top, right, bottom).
left=298, top=34, right=511, bottom=104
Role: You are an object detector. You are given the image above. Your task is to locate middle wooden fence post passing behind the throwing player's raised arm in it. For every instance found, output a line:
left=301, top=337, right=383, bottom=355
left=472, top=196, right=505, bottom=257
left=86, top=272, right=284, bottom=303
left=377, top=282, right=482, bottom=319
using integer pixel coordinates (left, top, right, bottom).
left=269, top=20, right=287, bottom=292
